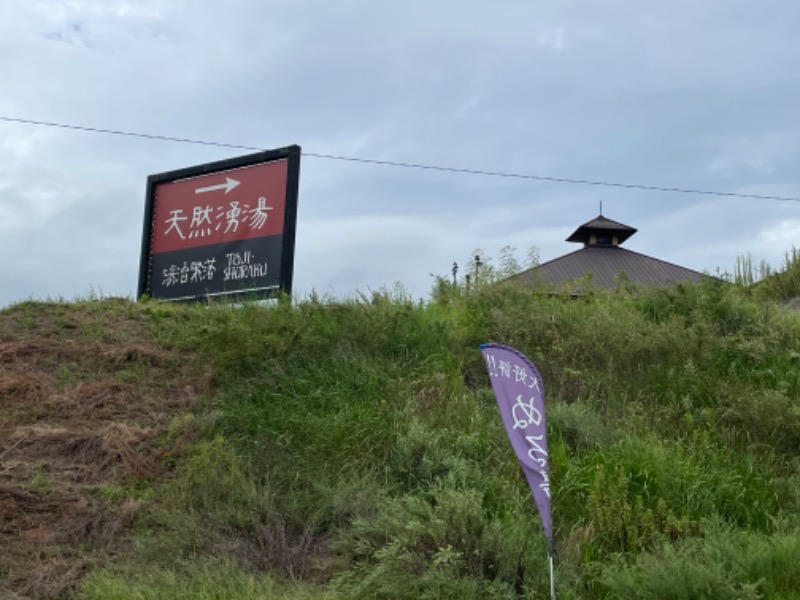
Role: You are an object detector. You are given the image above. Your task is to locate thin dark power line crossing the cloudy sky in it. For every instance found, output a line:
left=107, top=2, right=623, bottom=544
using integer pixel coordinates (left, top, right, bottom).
left=0, top=116, right=800, bottom=202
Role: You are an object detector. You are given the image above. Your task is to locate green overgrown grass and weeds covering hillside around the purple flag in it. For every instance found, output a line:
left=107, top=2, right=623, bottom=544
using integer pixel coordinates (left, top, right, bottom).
left=65, top=274, right=800, bottom=598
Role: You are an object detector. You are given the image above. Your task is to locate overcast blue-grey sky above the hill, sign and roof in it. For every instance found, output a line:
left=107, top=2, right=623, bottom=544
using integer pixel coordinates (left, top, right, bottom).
left=0, top=0, right=800, bottom=306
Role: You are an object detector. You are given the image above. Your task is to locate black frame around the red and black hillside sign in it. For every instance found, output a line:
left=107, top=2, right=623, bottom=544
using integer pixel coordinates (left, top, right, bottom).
left=136, top=145, right=301, bottom=302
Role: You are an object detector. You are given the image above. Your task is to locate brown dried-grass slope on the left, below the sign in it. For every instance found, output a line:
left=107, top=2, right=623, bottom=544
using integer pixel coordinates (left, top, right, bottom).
left=0, top=300, right=203, bottom=598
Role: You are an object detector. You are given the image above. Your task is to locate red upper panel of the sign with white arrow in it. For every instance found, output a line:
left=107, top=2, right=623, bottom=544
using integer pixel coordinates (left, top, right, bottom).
left=151, top=160, right=287, bottom=254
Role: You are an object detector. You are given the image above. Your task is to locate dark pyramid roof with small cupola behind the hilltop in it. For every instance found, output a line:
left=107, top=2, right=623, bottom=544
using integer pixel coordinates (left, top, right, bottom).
left=515, top=213, right=705, bottom=291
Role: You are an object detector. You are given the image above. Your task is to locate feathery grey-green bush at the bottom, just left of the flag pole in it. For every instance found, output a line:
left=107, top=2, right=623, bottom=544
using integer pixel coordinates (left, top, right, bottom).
left=336, top=476, right=547, bottom=599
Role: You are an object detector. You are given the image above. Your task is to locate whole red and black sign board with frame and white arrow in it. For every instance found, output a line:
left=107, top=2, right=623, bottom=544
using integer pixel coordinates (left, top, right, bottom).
left=137, top=146, right=300, bottom=300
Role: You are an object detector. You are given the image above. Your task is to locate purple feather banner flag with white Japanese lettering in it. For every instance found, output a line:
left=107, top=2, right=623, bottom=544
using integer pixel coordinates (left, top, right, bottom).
left=481, top=344, right=553, bottom=545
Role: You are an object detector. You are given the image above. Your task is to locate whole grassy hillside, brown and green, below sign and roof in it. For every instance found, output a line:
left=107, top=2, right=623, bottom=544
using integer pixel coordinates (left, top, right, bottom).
left=0, top=282, right=800, bottom=600
